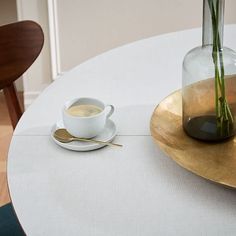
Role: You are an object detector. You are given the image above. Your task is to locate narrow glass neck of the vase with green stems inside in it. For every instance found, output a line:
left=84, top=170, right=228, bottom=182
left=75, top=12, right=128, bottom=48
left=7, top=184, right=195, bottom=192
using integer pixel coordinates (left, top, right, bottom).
left=202, top=0, right=225, bottom=48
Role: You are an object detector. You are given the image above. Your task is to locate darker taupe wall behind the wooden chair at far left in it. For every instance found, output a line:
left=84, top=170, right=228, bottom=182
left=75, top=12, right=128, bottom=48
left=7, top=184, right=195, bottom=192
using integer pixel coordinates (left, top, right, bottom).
left=0, top=0, right=23, bottom=91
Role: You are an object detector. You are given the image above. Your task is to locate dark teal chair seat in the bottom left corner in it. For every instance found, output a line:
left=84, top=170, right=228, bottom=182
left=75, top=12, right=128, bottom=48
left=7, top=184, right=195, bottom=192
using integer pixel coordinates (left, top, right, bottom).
left=0, top=203, right=25, bottom=236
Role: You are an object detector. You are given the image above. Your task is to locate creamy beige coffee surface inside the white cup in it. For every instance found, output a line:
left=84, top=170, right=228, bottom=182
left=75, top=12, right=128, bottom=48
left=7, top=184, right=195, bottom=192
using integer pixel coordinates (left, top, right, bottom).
left=66, top=104, right=102, bottom=117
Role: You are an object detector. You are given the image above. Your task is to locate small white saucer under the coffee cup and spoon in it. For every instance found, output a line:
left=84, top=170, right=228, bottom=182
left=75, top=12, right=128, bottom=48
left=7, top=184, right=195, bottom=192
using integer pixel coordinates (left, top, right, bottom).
left=51, top=119, right=116, bottom=152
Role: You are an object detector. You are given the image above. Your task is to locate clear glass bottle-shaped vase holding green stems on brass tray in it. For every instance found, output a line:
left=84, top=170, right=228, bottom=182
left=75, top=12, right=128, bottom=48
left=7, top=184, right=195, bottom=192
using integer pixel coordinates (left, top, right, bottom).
left=182, top=0, right=236, bottom=141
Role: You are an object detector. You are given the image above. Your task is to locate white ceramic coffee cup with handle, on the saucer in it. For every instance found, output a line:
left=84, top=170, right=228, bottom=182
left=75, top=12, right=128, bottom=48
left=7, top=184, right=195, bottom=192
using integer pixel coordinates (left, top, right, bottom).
left=62, top=97, right=114, bottom=138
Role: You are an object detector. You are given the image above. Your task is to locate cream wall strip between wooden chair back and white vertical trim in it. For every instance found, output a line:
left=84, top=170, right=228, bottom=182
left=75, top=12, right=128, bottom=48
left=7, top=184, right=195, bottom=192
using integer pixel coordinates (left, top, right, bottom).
left=17, top=0, right=52, bottom=107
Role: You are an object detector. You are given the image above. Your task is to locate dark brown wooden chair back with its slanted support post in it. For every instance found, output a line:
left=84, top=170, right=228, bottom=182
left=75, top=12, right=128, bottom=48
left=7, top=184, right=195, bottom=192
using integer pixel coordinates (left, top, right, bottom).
left=0, top=21, right=44, bottom=128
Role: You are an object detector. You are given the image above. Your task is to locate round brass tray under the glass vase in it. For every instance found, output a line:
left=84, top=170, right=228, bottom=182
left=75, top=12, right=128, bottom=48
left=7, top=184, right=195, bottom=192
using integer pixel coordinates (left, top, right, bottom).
left=150, top=90, right=236, bottom=188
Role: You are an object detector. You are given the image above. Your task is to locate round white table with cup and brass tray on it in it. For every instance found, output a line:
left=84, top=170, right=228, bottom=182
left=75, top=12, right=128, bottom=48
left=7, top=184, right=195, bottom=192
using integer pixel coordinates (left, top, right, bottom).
left=8, top=25, right=236, bottom=236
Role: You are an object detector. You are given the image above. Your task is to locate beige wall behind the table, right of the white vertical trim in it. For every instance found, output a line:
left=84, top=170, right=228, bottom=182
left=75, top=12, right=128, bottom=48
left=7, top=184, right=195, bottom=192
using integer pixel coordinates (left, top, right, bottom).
left=57, top=0, right=236, bottom=71
